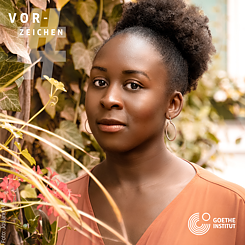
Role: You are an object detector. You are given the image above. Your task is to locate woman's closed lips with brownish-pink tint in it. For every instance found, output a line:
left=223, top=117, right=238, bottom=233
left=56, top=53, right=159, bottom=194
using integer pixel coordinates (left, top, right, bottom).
left=98, top=118, right=125, bottom=133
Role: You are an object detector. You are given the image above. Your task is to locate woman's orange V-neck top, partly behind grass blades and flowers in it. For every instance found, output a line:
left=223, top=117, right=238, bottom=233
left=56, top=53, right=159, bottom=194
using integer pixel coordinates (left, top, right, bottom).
left=51, top=163, right=245, bottom=245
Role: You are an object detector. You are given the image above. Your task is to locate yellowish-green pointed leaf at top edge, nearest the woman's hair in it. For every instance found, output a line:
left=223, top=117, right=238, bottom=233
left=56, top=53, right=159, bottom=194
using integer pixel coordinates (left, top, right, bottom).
left=76, top=0, right=98, bottom=26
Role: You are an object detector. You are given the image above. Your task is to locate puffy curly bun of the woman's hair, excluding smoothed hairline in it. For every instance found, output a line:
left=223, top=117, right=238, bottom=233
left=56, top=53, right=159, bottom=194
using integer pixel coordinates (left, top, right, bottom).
left=114, top=0, right=215, bottom=91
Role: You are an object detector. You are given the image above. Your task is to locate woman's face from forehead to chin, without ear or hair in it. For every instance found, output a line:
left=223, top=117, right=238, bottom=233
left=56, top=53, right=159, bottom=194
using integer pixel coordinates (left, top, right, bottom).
left=85, top=34, right=172, bottom=152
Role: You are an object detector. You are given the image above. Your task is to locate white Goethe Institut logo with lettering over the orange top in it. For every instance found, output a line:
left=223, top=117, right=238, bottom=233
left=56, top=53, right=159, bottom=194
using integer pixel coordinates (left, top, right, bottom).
left=188, top=213, right=236, bottom=236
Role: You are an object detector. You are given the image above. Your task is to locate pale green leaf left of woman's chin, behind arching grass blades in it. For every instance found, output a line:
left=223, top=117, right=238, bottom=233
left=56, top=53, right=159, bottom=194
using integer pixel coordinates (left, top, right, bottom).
left=55, top=121, right=84, bottom=149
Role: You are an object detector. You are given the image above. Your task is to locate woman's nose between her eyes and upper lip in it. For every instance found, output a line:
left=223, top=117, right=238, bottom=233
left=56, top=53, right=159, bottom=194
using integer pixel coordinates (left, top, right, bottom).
left=100, top=84, right=123, bottom=110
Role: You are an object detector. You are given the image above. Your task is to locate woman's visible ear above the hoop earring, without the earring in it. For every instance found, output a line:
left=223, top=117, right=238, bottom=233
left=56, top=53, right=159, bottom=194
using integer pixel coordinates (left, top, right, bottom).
left=166, top=91, right=184, bottom=119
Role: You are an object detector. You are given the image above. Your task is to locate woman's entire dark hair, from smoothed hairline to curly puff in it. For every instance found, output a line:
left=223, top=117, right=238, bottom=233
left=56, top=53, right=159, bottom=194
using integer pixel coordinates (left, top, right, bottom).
left=105, top=0, right=215, bottom=94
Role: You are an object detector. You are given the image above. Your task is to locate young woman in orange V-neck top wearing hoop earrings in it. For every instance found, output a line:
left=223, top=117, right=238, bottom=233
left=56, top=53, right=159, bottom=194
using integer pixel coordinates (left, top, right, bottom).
left=52, top=0, right=245, bottom=245
